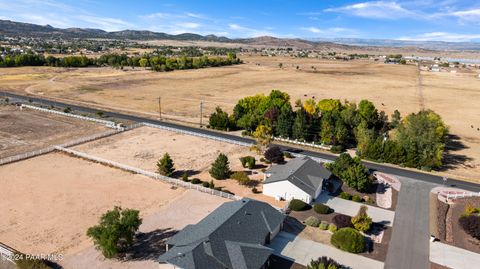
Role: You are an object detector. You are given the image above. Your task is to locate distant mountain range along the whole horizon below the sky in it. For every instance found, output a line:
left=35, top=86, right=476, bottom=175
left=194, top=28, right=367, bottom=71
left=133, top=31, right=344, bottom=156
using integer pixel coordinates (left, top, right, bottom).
left=0, top=20, right=480, bottom=51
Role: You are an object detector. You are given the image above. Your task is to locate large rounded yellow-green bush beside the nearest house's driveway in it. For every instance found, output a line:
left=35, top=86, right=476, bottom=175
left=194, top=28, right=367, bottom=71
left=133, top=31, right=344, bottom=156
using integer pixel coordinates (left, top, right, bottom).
left=330, top=227, right=365, bottom=253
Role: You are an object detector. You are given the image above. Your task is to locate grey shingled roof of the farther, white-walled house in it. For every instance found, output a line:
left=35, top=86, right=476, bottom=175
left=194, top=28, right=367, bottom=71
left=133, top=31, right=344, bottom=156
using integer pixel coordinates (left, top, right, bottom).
left=263, top=157, right=332, bottom=196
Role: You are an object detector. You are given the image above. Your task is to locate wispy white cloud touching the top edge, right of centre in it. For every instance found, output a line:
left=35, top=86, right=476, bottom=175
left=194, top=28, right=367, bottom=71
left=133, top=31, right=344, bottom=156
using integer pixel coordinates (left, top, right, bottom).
left=324, top=1, right=415, bottom=19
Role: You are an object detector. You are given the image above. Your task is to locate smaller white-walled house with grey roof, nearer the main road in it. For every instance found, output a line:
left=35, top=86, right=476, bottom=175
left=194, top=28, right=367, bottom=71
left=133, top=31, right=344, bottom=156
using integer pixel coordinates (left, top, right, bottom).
left=263, top=157, right=332, bottom=203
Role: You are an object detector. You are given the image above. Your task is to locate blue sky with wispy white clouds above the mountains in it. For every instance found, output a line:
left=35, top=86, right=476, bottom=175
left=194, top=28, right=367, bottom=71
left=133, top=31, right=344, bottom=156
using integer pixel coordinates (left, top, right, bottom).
left=0, top=0, right=480, bottom=42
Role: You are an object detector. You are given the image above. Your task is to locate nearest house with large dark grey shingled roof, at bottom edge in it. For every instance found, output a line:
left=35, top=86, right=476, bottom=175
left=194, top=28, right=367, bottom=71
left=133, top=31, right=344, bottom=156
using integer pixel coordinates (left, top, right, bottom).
left=158, top=199, right=285, bottom=269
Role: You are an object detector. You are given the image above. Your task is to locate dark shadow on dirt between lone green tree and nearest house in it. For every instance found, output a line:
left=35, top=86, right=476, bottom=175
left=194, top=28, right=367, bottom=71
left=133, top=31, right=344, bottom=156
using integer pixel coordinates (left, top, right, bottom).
left=124, top=228, right=178, bottom=261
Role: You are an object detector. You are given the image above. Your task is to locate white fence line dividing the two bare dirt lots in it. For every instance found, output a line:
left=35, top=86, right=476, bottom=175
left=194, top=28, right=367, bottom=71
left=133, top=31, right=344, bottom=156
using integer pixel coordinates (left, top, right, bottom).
left=55, top=146, right=242, bottom=200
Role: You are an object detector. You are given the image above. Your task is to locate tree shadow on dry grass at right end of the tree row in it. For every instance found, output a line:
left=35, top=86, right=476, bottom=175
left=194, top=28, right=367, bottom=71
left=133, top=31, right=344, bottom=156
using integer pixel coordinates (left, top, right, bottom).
left=437, top=134, right=473, bottom=171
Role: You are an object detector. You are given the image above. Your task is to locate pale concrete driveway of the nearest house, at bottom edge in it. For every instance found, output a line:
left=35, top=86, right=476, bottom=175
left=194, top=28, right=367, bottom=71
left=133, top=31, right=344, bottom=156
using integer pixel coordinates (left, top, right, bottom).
left=269, top=232, right=383, bottom=269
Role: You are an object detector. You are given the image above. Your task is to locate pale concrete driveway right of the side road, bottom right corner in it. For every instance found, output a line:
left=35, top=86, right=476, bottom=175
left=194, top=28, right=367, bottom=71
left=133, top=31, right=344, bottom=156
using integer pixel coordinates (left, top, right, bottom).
left=430, top=242, right=480, bottom=269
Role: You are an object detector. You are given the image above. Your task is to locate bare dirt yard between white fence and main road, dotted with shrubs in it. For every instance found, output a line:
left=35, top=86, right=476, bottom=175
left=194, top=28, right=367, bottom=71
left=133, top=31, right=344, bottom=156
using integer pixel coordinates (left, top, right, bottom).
left=74, top=127, right=284, bottom=206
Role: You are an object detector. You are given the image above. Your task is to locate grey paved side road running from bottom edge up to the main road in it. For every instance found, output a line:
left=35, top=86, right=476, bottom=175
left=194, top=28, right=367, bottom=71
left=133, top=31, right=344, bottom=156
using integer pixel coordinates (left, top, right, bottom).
left=385, top=178, right=437, bottom=269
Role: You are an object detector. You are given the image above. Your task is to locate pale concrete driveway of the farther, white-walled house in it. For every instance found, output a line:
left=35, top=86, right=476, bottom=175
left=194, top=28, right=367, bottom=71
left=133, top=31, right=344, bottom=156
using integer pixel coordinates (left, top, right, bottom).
left=315, top=193, right=395, bottom=224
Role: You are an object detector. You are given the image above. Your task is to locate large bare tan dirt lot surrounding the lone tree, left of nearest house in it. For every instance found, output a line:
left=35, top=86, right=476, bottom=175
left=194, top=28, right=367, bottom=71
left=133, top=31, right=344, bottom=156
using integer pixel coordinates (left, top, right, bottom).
left=0, top=153, right=188, bottom=255
